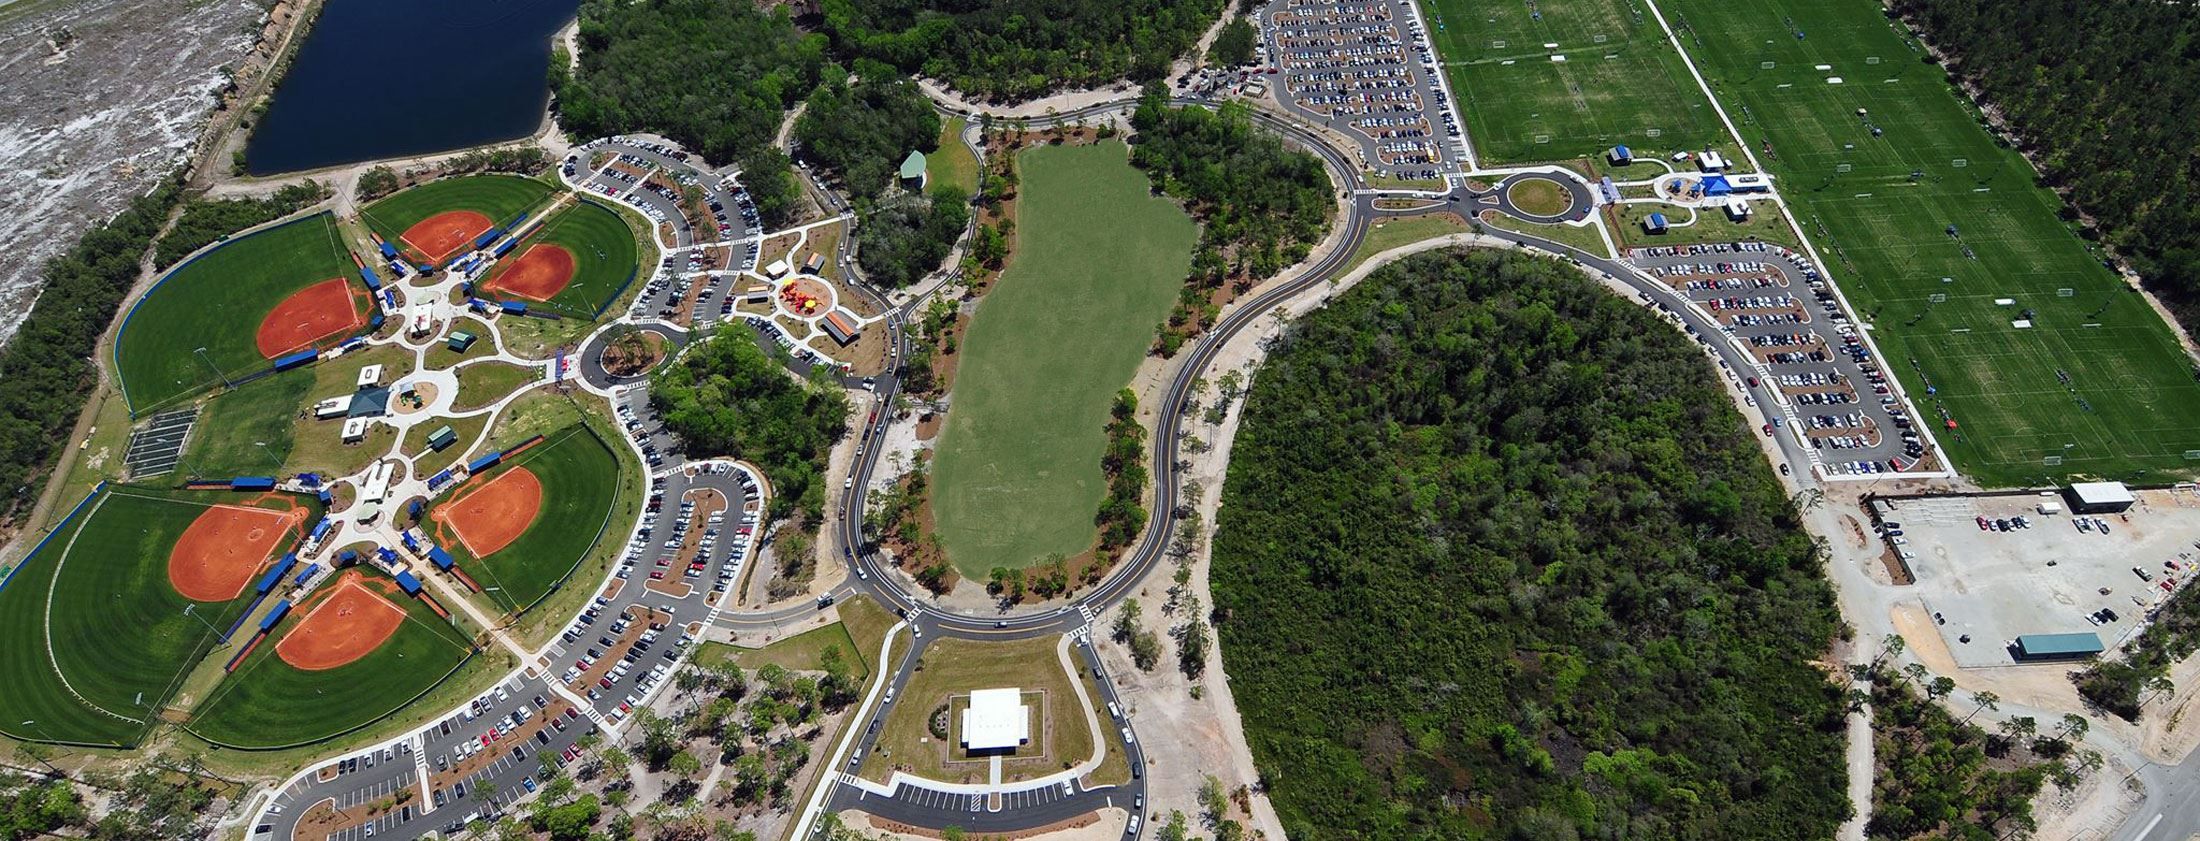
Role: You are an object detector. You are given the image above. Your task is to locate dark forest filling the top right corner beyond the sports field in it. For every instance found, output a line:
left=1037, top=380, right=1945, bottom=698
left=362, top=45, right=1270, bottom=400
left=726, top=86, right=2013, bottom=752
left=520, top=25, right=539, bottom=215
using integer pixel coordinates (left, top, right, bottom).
left=1894, top=0, right=2200, bottom=330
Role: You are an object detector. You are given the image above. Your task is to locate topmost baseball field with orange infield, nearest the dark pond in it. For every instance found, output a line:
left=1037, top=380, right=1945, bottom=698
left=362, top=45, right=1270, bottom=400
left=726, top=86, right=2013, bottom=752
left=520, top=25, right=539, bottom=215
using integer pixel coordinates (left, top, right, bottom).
left=359, top=174, right=552, bottom=264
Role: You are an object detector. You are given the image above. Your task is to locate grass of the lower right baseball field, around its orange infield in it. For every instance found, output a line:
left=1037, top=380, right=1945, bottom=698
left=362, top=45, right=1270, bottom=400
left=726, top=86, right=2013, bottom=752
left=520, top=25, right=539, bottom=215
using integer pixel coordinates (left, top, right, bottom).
left=431, top=425, right=629, bottom=610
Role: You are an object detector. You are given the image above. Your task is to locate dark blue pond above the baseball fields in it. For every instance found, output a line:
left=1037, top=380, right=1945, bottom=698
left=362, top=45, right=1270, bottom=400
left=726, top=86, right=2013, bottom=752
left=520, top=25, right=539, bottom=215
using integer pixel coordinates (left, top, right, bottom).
left=244, top=0, right=581, bottom=176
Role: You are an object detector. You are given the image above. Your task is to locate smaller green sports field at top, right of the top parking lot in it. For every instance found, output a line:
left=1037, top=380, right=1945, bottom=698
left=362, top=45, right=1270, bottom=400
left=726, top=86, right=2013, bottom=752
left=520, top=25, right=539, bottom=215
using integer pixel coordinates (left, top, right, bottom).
left=1421, top=0, right=1733, bottom=163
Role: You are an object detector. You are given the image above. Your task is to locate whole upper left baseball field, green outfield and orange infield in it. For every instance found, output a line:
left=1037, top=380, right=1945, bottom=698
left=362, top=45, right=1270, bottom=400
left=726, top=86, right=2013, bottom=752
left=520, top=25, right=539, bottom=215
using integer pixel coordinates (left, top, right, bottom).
left=114, top=214, right=367, bottom=412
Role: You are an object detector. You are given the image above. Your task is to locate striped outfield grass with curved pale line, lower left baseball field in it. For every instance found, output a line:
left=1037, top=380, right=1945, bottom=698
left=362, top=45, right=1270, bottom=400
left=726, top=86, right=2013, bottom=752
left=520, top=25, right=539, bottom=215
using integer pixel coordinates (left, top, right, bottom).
left=0, top=487, right=305, bottom=744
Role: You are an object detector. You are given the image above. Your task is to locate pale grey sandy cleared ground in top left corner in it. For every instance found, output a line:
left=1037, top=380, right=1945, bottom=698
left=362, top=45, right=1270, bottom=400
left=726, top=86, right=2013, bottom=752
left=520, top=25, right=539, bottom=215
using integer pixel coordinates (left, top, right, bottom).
left=0, top=0, right=262, bottom=341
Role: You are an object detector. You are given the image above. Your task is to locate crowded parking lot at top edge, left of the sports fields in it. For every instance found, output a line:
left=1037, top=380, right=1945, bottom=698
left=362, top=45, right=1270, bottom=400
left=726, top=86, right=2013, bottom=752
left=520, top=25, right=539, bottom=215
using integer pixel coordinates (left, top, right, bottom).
left=1258, top=0, right=1465, bottom=178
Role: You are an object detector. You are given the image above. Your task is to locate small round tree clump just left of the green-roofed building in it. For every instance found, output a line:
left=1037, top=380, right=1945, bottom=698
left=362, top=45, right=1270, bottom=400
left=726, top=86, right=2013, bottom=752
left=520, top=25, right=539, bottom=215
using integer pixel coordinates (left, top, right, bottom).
left=794, top=62, right=939, bottom=198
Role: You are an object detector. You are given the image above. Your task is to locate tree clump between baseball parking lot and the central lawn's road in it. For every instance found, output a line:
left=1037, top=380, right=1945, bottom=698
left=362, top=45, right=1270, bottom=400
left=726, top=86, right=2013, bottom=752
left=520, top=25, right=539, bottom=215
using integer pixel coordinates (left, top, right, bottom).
left=649, top=330, right=849, bottom=526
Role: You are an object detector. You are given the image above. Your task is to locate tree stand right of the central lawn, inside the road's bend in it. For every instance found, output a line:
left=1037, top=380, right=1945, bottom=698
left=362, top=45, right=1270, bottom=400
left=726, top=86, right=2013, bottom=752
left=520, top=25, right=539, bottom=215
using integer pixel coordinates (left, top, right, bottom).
left=1131, top=88, right=1335, bottom=354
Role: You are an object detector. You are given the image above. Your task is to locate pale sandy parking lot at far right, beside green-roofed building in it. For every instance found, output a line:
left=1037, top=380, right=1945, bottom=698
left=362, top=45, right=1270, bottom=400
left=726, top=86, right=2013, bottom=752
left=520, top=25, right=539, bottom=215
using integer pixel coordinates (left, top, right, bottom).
left=1881, top=491, right=2200, bottom=669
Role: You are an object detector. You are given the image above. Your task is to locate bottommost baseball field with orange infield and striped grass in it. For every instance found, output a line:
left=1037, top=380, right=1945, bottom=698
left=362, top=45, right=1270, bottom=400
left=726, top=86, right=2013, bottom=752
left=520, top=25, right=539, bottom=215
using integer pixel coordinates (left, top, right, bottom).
left=189, top=572, right=473, bottom=749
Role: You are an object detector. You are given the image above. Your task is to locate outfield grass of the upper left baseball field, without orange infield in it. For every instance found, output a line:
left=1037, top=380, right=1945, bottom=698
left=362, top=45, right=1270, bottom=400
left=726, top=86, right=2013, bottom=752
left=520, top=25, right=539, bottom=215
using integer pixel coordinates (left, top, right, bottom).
left=114, top=214, right=365, bottom=414
